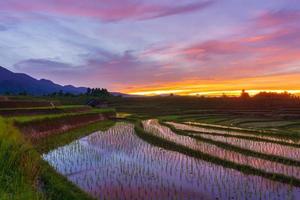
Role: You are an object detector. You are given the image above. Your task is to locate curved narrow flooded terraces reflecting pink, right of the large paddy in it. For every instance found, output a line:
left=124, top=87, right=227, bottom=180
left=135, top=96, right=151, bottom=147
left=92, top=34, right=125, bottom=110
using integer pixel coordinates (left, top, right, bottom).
left=138, top=120, right=300, bottom=185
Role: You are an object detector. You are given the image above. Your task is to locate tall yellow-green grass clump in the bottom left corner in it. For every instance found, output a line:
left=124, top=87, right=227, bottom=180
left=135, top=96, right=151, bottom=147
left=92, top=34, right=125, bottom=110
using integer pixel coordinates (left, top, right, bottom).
left=0, top=118, right=43, bottom=200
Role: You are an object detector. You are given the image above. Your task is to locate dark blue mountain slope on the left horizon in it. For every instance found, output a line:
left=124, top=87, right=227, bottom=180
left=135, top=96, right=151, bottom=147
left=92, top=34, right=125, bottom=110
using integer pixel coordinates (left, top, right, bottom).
left=0, top=66, right=87, bottom=95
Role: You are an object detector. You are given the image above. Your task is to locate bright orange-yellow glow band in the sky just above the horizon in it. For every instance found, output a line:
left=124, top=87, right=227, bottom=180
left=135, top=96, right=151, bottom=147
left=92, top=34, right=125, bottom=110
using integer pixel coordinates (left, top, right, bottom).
left=123, top=74, right=300, bottom=96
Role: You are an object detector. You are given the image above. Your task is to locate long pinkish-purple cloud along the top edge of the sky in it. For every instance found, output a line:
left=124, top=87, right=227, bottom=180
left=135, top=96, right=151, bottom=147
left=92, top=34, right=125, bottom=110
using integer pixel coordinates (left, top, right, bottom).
left=0, top=0, right=214, bottom=21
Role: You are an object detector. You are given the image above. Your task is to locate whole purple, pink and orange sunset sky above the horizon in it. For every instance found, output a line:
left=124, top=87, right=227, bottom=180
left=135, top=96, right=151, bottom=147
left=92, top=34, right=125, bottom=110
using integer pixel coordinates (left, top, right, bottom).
left=0, top=0, right=300, bottom=95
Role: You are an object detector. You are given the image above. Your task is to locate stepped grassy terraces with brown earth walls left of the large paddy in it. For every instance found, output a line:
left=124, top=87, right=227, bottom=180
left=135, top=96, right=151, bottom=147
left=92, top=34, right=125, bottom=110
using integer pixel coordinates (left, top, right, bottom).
left=0, top=98, right=116, bottom=199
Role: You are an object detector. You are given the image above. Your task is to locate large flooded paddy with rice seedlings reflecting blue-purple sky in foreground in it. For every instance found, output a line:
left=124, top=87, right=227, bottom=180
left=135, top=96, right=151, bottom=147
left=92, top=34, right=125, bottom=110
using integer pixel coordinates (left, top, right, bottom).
left=43, top=123, right=300, bottom=199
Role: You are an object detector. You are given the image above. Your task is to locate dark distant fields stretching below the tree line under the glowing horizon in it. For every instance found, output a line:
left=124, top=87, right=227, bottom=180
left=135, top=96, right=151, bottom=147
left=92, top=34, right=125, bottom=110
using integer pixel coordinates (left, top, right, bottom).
left=21, top=95, right=300, bottom=139
